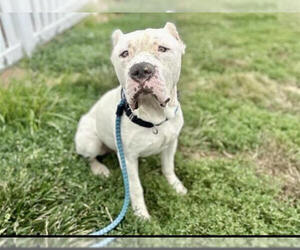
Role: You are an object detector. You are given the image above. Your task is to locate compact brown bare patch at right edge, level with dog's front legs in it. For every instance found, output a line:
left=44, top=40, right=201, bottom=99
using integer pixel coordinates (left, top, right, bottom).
left=252, top=139, right=300, bottom=199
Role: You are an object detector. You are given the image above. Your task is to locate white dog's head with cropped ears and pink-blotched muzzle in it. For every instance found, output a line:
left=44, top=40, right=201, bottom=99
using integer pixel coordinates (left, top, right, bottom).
left=111, top=22, right=185, bottom=110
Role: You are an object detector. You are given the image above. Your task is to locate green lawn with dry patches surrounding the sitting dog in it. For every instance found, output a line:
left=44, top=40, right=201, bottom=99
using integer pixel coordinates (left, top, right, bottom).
left=0, top=13, right=300, bottom=235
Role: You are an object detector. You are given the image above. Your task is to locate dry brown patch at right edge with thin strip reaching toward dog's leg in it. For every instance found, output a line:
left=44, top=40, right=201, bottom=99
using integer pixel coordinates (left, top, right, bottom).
left=179, top=134, right=300, bottom=200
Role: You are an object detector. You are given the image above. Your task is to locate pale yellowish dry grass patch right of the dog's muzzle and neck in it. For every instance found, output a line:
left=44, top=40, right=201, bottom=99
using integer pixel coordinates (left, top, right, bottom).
left=188, top=72, right=300, bottom=112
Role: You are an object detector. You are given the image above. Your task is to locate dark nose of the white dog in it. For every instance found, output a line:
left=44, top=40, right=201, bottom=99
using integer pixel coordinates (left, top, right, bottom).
left=129, top=62, right=155, bottom=83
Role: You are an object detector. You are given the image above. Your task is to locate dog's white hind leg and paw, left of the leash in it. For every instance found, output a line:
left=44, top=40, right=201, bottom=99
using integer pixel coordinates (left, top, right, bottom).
left=75, top=114, right=109, bottom=177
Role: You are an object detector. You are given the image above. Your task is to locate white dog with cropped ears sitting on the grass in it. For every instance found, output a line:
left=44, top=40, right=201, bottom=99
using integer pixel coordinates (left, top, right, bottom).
left=75, top=23, right=187, bottom=219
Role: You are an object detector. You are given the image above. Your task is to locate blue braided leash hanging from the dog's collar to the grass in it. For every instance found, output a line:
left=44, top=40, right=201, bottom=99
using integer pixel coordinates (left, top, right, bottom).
left=91, top=98, right=130, bottom=235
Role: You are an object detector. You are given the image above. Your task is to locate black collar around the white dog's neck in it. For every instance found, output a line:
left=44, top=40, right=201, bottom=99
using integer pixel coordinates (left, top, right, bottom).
left=117, top=89, right=168, bottom=128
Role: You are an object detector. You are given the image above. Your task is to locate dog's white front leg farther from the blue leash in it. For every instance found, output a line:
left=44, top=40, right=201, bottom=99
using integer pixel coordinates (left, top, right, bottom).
left=161, top=139, right=187, bottom=194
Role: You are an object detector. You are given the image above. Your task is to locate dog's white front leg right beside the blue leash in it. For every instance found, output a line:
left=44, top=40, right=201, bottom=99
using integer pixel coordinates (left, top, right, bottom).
left=125, top=156, right=150, bottom=219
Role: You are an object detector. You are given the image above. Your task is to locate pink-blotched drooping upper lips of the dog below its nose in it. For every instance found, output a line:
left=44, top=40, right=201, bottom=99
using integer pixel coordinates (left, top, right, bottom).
left=126, top=72, right=170, bottom=110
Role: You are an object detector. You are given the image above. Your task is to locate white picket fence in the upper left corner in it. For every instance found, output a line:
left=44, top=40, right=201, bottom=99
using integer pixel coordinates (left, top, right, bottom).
left=0, top=0, right=89, bottom=70
